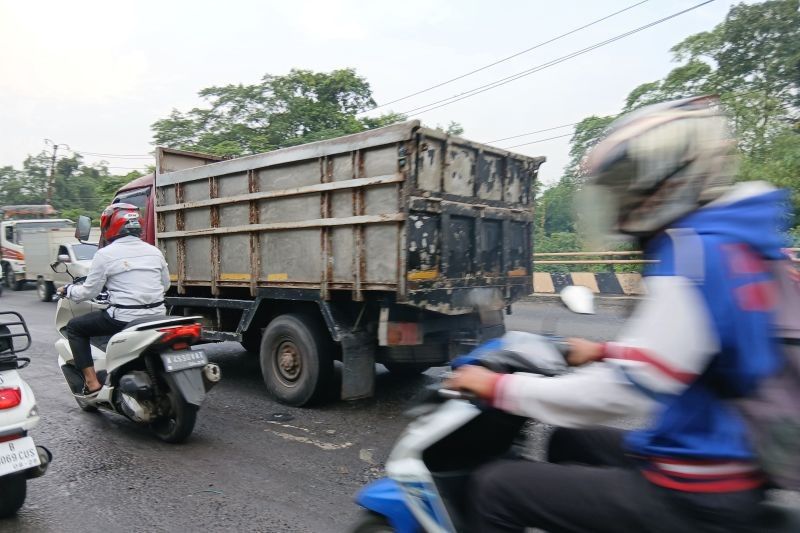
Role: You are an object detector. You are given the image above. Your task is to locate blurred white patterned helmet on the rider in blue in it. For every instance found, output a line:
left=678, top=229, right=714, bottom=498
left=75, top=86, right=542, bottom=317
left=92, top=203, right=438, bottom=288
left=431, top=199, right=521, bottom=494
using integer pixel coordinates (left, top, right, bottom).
left=581, top=96, right=736, bottom=239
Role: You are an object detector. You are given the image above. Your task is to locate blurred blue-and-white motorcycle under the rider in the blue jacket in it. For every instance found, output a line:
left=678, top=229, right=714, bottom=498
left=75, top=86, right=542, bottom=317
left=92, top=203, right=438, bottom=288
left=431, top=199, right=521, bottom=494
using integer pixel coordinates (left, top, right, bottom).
left=351, top=287, right=800, bottom=533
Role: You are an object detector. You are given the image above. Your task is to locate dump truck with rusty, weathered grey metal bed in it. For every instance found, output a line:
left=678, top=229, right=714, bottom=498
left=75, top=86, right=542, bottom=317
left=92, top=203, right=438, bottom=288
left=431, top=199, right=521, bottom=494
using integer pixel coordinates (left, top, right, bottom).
left=109, top=121, right=545, bottom=405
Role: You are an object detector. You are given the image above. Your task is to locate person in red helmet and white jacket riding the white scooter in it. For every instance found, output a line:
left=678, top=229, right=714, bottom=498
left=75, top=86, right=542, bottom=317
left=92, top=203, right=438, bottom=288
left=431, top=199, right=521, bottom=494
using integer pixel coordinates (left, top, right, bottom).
left=59, top=203, right=169, bottom=397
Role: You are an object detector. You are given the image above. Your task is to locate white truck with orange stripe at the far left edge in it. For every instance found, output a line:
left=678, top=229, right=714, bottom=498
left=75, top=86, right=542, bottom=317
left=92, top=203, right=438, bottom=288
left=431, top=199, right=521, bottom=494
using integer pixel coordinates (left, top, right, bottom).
left=0, top=205, right=75, bottom=291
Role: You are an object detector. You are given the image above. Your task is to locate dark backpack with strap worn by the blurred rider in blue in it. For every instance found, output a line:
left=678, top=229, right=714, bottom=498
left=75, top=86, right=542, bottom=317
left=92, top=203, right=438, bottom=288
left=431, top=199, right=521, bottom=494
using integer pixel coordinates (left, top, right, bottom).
left=667, top=229, right=800, bottom=490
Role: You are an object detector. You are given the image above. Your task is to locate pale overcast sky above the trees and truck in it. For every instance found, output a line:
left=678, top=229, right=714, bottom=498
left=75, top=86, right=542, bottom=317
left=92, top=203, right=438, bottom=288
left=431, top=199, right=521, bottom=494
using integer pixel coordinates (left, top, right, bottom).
left=0, top=0, right=732, bottom=183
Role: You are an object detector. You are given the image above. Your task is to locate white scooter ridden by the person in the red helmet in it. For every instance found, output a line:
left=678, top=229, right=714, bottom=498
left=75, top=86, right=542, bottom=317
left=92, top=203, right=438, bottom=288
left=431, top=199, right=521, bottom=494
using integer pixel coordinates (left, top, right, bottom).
left=51, top=262, right=221, bottom=443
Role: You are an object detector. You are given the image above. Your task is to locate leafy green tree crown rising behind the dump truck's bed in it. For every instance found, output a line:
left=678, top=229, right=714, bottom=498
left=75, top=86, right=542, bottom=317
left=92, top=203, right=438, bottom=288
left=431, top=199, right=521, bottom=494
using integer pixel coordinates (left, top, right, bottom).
left=152, top=69, right=404, bottom=156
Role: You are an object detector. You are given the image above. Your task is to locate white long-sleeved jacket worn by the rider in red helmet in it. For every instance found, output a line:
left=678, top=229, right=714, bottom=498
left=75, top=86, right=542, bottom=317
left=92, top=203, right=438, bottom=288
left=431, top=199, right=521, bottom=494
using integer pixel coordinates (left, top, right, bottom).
left=67, top=236, right=169, bottom=322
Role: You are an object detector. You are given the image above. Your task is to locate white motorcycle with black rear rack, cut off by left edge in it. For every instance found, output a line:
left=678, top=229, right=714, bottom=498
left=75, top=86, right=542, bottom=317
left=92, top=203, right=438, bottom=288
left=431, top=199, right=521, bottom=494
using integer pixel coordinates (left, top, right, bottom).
left=0, top=311, right=53, bottom=518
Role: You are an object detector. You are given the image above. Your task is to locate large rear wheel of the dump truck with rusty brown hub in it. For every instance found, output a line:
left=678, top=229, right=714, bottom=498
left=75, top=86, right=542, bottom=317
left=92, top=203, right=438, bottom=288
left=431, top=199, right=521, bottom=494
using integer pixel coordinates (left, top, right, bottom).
left=260, top=314, right=334, bottom=407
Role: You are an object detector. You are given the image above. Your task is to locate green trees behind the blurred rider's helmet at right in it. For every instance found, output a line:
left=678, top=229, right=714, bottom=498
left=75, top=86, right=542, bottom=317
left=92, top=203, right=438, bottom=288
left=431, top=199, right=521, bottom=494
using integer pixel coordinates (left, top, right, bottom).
left=535, top=0, right=800, bottom=264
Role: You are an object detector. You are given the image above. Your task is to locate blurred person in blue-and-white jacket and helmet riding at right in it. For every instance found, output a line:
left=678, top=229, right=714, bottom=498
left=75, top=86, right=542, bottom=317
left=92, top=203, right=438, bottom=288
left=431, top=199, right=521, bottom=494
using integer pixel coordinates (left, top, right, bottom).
left=449, top=97, right=788, bottom=532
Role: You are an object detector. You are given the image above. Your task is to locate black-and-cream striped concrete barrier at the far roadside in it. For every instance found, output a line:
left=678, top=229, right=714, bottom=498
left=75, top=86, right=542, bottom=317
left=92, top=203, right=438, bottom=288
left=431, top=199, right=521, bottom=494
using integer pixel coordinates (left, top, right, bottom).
left=533, top=272, right=644, bottom=296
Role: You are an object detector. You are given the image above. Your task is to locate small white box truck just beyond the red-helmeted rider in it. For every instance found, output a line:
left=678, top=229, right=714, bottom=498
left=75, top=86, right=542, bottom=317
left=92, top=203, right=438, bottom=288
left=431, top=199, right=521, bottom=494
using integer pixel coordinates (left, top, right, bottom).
left=25, top=228, right=97, bottom=302
